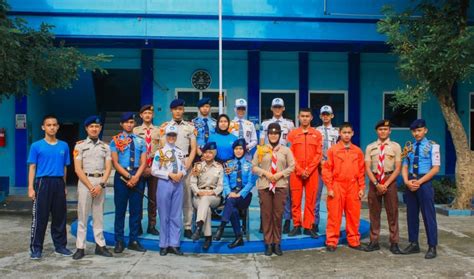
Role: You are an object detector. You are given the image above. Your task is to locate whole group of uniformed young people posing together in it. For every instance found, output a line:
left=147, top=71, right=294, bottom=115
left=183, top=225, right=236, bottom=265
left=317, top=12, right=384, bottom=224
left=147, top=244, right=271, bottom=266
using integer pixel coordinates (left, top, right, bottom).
left=28, top=98, right=440, bottom=259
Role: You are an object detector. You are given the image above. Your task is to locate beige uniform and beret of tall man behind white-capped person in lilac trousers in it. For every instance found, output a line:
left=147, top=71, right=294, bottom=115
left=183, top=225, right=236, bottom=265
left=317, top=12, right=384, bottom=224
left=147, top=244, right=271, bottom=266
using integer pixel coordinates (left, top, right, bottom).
left=160, top=99, right=197, bottom=234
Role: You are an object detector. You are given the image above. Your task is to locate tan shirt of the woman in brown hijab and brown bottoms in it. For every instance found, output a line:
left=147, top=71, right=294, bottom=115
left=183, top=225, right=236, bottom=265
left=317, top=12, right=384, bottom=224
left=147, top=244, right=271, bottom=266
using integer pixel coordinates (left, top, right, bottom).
left=252, top=144, right=295, bottom=190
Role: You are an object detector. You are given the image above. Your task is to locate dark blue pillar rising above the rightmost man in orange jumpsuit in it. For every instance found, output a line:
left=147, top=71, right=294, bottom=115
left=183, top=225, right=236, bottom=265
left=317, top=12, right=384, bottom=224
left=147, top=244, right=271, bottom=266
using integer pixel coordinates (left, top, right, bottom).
left=347, top=52, right=361, bottom=146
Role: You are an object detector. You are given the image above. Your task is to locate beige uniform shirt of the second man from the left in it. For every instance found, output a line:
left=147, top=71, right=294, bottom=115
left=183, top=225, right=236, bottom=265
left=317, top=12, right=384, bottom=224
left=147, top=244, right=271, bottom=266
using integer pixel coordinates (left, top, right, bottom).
left=74, top=138, right=112, bottom=174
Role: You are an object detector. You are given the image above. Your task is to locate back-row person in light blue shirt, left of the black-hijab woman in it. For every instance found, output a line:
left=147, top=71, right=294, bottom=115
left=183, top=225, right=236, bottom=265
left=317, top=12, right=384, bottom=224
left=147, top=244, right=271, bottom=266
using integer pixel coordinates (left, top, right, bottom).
left=193, top=97, right=216, bottom=161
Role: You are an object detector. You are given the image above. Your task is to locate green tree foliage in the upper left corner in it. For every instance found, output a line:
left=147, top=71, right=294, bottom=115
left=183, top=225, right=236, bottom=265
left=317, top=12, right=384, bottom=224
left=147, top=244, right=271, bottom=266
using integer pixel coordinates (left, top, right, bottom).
left=0, top=0, right=111, bottom=102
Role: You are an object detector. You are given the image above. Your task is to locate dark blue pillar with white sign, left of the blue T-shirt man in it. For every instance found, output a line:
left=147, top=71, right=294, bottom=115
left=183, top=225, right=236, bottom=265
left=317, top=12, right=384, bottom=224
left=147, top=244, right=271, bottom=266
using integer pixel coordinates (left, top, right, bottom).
left=15, top=96, right=28, bottom=187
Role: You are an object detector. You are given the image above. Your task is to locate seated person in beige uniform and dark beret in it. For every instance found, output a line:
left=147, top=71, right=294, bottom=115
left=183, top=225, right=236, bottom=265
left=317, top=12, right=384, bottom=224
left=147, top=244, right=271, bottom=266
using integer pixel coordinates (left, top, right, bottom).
left=190, top=142, right=224, bottom=250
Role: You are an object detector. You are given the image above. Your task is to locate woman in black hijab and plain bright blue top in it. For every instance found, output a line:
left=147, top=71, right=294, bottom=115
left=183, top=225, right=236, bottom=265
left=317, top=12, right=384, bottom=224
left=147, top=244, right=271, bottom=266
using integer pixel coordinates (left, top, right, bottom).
left=208, top=114, right=238, bottom=164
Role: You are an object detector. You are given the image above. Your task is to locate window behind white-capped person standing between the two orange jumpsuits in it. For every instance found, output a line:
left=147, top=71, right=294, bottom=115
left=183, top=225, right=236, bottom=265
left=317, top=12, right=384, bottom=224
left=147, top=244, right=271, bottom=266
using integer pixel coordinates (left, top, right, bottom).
left=309, top=91, right=347, bottom=127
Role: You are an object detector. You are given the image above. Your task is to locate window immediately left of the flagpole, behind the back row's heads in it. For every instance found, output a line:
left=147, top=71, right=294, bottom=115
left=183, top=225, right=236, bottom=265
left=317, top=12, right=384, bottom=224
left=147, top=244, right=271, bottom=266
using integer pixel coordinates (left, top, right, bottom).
left=176, top=89, right=226, bottom=121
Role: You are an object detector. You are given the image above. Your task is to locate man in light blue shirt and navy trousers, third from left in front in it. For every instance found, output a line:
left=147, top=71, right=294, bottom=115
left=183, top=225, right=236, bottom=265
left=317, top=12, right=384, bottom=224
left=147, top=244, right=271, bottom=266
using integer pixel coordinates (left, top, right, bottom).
left=110, top=112, right=146, bottom=253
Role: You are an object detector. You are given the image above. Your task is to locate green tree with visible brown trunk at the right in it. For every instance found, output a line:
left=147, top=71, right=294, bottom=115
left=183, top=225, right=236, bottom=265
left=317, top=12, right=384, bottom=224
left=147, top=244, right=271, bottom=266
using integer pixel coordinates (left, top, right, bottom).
left=378, top=0, right=474, bottom=209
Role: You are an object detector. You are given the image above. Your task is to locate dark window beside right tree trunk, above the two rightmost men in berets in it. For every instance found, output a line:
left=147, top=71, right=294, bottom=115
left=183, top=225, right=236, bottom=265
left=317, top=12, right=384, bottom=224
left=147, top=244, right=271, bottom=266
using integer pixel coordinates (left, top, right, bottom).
left=382, top=92, right=420, bottom=129
